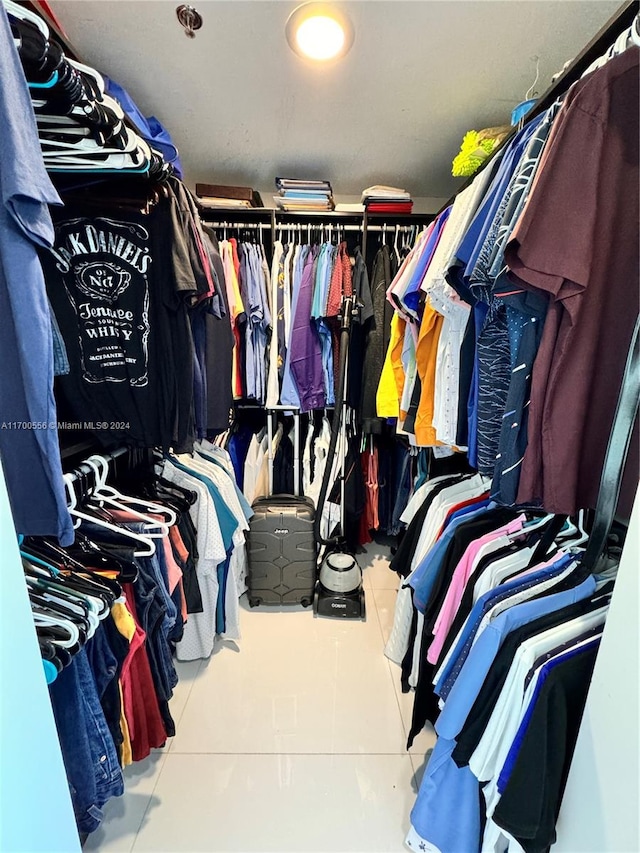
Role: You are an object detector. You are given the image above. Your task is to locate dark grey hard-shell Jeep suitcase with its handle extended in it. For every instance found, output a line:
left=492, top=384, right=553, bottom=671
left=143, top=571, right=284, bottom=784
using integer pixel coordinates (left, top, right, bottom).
left=247, top=412, right=316, bottom=607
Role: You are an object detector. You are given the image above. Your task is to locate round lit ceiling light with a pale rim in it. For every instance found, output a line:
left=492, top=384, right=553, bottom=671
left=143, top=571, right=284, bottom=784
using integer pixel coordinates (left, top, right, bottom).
left=286, top=3, right=354, bottom=62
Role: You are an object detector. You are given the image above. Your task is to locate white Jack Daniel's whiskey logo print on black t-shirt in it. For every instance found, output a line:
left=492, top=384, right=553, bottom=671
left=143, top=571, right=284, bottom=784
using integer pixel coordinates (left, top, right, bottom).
left=52, top=219, right=152, bottom=388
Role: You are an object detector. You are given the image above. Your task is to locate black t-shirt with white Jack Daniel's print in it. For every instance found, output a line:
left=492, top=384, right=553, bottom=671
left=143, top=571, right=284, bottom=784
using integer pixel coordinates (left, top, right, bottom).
left=41, top=200, right=195, bottom=447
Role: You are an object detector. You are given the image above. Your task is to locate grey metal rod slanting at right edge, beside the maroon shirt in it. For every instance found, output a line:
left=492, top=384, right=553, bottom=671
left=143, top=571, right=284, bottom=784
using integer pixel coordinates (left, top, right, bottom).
left=582, top=317, right=640, bottom=572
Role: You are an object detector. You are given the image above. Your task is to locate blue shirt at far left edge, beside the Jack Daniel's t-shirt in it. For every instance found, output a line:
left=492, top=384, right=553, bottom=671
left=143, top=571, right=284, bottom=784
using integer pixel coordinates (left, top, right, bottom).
left=0, top=7, right=74, bottom=545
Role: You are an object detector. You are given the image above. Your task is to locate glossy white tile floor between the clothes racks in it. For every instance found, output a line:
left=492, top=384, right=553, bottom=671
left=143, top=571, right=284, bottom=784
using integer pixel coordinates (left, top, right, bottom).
left=84, top=545, right=435, bottom=853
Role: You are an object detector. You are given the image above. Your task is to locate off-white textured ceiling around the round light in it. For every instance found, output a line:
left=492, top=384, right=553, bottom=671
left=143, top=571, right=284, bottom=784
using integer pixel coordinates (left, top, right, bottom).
left=51, top=0, right=618, bottom=202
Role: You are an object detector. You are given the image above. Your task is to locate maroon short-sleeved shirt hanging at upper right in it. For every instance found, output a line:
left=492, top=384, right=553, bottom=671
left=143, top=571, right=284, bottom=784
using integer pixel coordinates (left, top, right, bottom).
left=506, top=47, right=640, bottom=514
